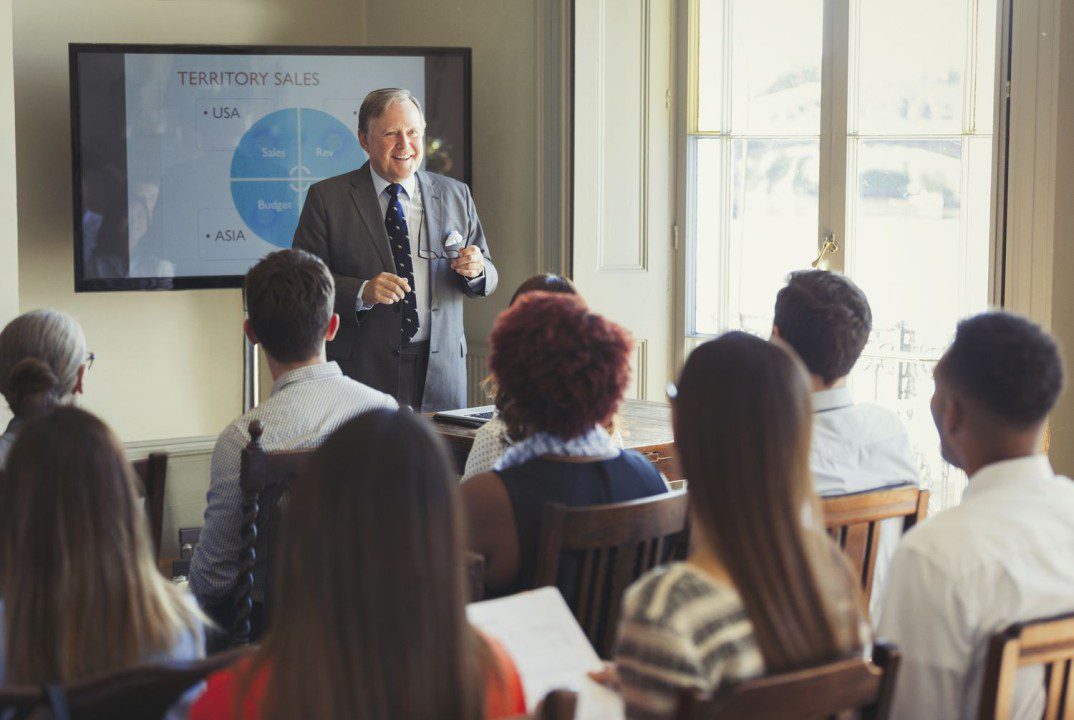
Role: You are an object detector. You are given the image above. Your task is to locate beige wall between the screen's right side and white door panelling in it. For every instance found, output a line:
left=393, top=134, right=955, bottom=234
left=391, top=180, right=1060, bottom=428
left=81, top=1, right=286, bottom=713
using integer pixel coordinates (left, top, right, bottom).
left=366, top=0, right=547, bottom=354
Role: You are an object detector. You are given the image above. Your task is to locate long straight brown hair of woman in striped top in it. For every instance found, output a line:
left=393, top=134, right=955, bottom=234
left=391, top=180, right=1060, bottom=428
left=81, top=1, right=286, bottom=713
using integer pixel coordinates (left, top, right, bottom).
left=674, top=332, right=863, bottom=673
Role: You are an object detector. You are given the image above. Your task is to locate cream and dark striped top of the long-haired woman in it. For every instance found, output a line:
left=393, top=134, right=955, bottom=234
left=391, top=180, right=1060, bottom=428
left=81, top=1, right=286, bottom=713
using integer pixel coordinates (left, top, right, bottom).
left=615, top=562, right=765, bottom=720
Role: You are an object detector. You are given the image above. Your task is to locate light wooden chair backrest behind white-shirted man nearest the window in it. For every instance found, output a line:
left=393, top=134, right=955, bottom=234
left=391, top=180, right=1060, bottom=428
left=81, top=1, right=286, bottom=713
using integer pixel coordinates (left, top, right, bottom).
left=821, top=485, right=929, bottom=603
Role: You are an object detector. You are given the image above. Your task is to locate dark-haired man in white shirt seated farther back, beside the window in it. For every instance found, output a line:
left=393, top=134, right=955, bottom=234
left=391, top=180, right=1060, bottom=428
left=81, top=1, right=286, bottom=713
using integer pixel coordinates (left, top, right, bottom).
left=772, top=270, right=920, bottom=617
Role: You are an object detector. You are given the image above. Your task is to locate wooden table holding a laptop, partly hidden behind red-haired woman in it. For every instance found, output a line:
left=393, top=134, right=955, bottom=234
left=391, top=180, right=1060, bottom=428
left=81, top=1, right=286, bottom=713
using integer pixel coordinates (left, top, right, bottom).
left=430, top=400, right=682, bottom=480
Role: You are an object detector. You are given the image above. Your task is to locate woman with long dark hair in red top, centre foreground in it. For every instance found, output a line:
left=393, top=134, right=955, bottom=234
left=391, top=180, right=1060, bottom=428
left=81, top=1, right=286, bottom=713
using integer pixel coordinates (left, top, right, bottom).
left=191, top=411, right=525, bottom=720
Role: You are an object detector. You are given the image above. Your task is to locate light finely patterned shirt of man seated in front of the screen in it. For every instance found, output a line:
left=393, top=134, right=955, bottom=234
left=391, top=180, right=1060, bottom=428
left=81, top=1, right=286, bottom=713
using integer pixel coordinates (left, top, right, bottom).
left=190, top=362, right=398, bottom=607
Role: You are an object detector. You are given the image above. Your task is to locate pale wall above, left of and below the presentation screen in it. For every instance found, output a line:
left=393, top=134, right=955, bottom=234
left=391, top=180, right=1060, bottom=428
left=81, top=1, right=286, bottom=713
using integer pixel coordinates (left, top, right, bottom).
left=13, top=0, right=365, bottom=441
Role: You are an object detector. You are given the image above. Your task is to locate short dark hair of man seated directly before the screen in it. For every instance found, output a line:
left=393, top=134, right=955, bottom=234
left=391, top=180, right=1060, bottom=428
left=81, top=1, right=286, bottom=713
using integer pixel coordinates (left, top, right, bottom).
left=243, top=249, right=335, bottom=362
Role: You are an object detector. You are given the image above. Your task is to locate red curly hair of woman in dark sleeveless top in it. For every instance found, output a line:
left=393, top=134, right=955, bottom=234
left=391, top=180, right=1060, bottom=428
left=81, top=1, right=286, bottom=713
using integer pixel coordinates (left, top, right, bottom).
left=489, top=292, right=634, bottom=440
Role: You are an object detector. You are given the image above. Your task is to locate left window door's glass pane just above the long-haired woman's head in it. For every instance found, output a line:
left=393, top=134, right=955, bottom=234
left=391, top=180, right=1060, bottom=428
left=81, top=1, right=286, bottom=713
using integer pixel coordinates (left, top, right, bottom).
left=695, top=139, right=819, bottom=336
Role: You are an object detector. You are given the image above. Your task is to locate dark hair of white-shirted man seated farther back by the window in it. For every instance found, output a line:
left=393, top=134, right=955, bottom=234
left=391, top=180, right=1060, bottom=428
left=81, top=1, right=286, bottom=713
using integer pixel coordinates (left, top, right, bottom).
left=772, top=270, right=872, bottom=385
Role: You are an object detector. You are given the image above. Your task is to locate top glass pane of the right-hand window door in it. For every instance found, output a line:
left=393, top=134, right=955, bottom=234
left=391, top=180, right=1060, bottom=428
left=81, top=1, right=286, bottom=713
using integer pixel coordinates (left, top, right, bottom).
left=851, top=0, right=970, bottom=134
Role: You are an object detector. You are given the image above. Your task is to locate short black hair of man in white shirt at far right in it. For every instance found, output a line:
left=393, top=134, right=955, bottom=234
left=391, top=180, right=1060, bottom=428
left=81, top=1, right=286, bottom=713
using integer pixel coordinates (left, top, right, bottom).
left=937, top=312, right=1063, bottom=428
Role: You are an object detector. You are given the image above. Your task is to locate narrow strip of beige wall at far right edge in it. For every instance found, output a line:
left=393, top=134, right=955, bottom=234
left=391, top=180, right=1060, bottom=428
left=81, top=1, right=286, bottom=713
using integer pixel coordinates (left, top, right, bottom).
left=1051, top=0, right=1074, bottom=476
